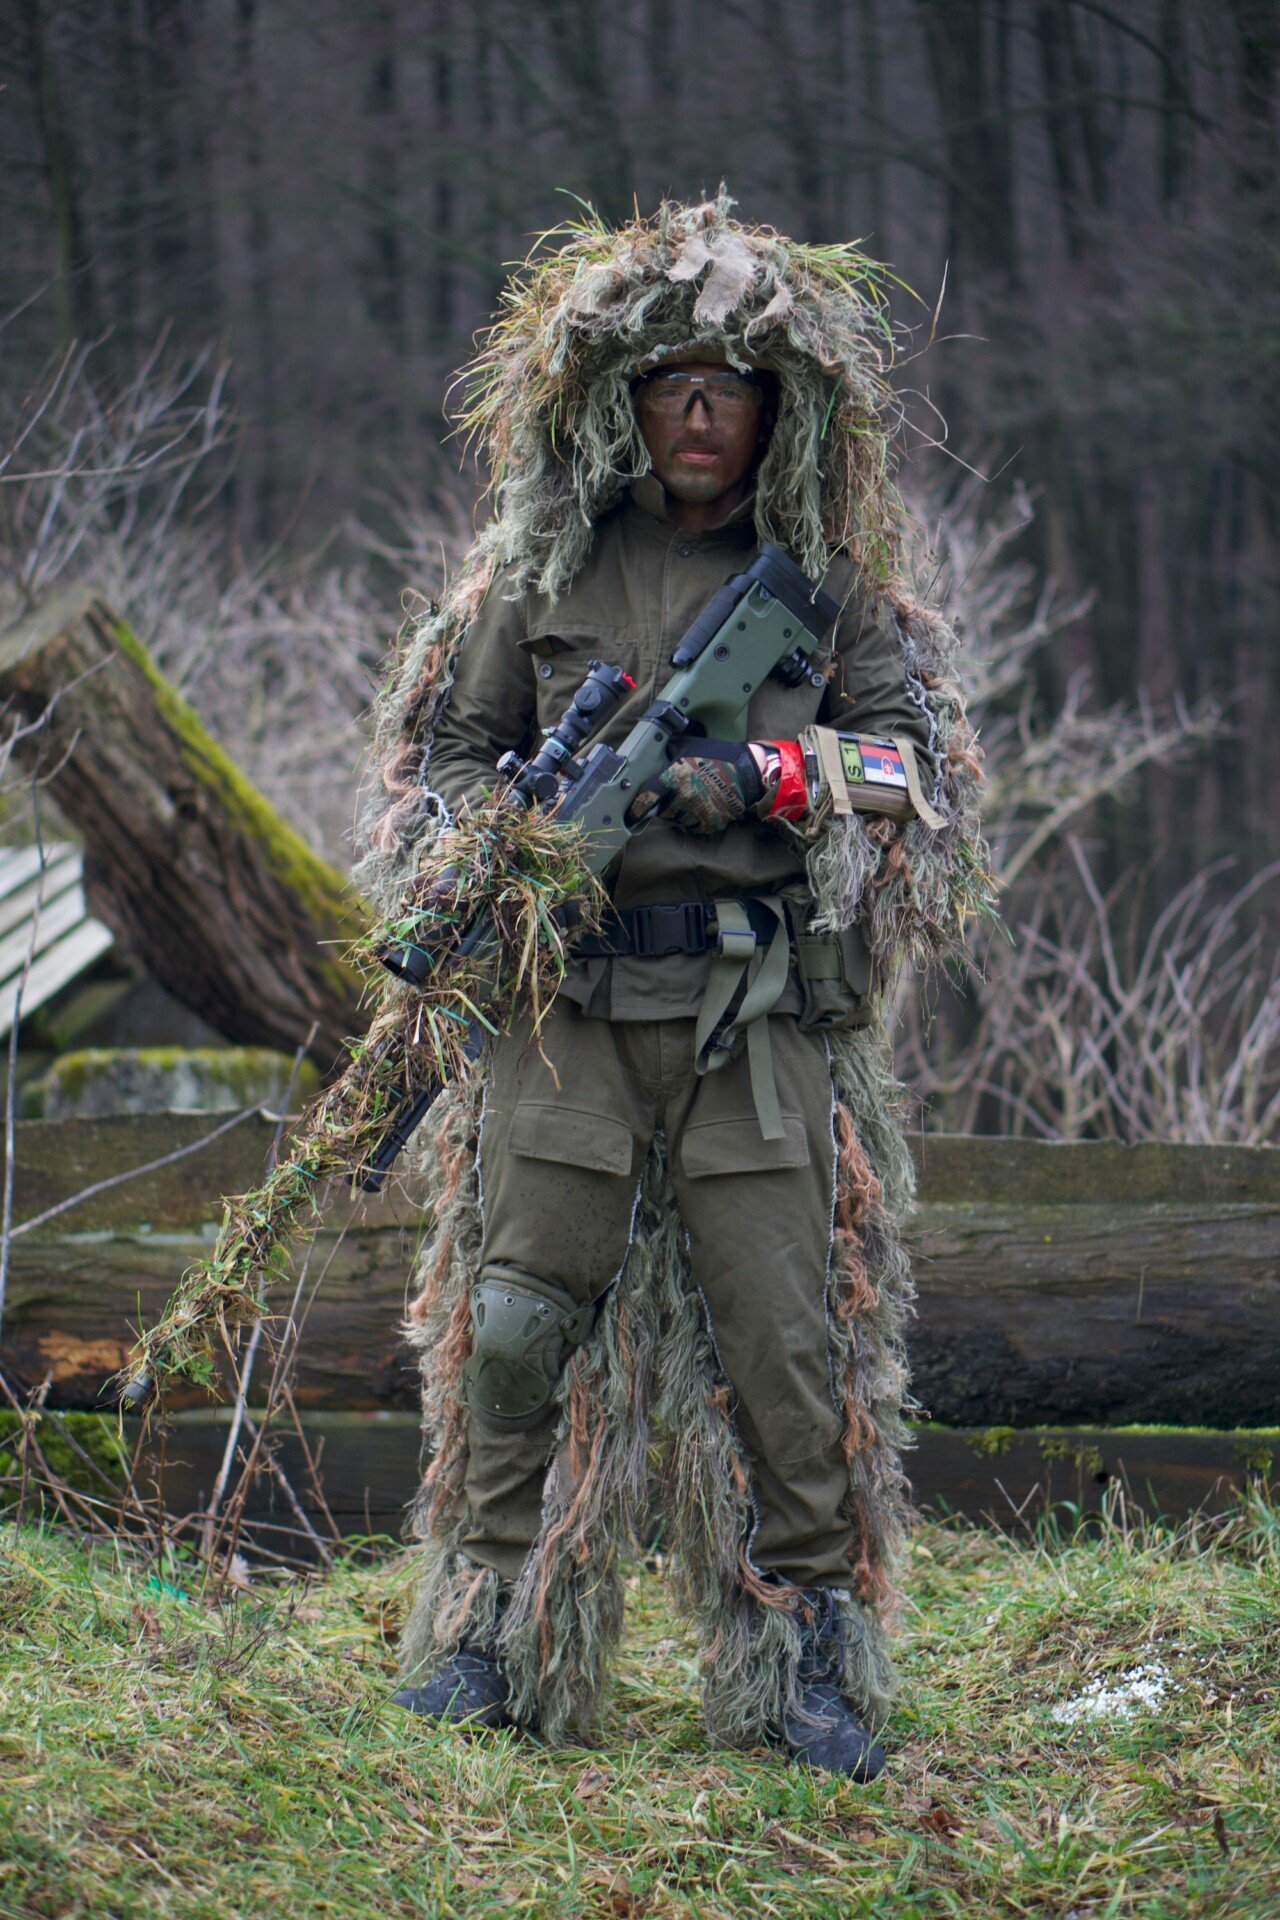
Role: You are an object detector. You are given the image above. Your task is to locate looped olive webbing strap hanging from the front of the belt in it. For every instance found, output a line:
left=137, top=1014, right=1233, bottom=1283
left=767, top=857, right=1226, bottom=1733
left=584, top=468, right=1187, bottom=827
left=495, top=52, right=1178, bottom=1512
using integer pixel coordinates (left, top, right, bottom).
left=693, top=893, right=791, bottom=1140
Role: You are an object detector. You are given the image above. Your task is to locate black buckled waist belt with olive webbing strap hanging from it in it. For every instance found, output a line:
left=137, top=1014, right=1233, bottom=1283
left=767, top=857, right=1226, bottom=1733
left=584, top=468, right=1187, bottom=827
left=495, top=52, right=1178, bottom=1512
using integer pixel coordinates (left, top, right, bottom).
left=557, top=895, right=841, bottom=1140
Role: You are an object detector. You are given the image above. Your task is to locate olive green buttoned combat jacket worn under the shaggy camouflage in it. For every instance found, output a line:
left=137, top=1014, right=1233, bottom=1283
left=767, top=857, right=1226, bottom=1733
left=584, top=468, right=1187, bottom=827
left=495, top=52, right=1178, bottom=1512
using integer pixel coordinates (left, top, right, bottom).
left=426, top=474, right=931, bottom=1025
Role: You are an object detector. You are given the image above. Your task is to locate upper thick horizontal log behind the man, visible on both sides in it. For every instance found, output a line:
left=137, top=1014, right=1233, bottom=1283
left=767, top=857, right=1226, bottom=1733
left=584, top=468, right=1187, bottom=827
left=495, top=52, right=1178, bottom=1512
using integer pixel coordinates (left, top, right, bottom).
left=0, top=1114, right=1280, bottom=1427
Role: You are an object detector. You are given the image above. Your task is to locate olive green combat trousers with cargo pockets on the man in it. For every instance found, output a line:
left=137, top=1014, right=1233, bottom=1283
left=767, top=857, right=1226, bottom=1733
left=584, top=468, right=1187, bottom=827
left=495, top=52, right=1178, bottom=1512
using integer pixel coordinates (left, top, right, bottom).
left=461, top=1000, right=852, bottom=1586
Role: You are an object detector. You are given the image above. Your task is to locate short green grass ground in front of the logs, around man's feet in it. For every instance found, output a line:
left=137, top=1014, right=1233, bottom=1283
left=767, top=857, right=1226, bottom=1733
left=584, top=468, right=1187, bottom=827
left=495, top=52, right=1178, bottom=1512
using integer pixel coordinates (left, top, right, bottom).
left=0, top=1505, right=1280, bottom=1920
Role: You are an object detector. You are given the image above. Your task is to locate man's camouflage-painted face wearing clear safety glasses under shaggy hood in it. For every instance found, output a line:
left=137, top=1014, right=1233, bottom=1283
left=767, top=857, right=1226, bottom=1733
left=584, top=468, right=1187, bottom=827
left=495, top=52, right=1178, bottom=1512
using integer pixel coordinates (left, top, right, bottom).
left=635, top=361, right=771, bottom=505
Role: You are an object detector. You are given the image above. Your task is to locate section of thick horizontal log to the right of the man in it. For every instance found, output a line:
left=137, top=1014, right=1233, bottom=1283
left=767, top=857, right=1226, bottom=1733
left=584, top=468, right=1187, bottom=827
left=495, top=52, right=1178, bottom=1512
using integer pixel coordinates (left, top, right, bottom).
left=910, top=1135, right=1280, bottom=1427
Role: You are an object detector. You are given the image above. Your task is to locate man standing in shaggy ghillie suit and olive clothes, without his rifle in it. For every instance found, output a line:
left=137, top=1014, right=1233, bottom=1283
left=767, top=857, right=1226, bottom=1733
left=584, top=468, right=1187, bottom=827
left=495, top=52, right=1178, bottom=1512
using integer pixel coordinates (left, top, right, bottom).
left=361, top=194, right=984, bottom=1780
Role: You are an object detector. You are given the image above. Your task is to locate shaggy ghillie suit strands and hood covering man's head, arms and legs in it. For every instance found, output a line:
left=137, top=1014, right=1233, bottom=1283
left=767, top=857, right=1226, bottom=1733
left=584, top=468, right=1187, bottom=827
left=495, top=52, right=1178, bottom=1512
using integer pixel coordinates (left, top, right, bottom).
left=357, top=192, right=986, bottom=1743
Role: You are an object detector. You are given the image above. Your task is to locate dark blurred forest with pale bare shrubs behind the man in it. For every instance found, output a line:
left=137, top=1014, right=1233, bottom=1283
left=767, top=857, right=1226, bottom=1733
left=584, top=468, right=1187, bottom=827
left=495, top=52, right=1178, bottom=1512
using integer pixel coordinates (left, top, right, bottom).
left=0, top=0, right=1280, bottom=1139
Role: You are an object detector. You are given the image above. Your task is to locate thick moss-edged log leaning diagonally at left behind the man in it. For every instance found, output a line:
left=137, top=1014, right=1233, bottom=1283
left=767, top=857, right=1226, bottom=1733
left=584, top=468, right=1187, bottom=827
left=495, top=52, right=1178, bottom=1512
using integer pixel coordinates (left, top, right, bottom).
left=0, top=591, right=363, bottom=1071
